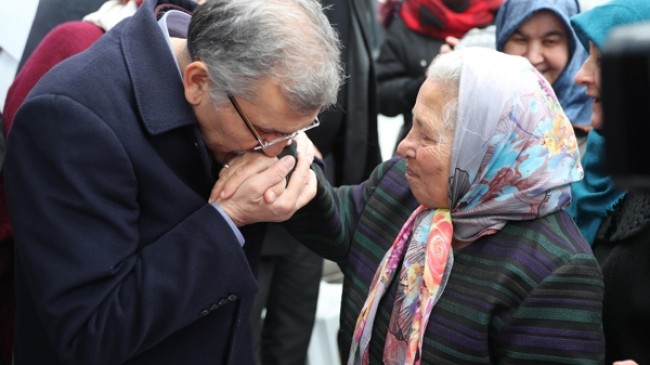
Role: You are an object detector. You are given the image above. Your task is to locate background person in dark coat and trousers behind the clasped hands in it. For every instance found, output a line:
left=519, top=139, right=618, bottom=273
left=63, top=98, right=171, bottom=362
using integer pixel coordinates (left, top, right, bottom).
left=251, top=0, right=381, bottom=365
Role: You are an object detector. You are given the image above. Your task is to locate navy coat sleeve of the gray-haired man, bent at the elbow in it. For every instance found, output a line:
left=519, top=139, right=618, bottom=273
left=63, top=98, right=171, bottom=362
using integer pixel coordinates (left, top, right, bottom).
left=5, top=95, right=256, bottom=365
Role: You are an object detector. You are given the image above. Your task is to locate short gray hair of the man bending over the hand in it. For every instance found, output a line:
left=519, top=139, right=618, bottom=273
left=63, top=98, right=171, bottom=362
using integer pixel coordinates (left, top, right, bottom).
left=187, top=0, right=343, bottom=114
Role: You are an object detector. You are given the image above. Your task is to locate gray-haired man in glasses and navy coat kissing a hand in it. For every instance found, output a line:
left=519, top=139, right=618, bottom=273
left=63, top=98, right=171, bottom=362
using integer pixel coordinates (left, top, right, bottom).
left=4, top=0, right=342, bottom=365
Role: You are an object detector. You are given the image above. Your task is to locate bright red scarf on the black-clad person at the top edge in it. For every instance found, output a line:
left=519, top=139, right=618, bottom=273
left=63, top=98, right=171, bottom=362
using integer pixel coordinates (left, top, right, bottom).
left=399, top=0, right=504, bottom=39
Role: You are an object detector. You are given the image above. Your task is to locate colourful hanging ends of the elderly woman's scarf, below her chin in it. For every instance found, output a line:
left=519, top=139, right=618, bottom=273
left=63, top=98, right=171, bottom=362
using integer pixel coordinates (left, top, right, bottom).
left=348, top=205, right=454, bottom=365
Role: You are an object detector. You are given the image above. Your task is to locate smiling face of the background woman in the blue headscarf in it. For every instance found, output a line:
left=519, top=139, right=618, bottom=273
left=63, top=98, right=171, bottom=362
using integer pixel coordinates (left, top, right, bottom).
left=503, top=10, right=569, bottom=85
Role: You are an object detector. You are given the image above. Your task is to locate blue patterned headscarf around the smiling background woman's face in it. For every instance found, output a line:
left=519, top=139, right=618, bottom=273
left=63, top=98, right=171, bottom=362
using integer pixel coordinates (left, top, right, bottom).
left=495, top=0, right=588, bottom=126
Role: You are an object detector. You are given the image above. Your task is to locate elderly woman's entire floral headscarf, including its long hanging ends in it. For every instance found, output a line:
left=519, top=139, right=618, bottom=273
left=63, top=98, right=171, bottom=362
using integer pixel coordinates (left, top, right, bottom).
left=347, top=48, right=583, bottom=365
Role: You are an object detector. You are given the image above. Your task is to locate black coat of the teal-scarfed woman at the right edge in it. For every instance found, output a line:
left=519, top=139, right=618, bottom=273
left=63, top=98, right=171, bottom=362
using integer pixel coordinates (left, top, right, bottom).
left=594, top=192, right=650, bottom=364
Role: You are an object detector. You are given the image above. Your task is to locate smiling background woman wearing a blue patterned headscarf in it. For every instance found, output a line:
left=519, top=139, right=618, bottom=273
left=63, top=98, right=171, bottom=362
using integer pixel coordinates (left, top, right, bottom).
left=495, top=0, right=591, bottom=152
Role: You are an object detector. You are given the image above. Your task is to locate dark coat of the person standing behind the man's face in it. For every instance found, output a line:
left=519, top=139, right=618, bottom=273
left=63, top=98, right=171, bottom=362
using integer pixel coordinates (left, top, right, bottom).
left=307, top=0, right=381, bottom=185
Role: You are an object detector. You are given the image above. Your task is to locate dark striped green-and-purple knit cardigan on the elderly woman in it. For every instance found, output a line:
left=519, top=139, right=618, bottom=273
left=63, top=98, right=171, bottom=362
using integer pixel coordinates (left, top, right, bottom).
left=287, top=159, right=604, bottom=364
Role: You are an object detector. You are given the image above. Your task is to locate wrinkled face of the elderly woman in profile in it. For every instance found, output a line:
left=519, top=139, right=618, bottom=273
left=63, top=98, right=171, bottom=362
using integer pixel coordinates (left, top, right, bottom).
left=397, top=80, right=454, bottom=208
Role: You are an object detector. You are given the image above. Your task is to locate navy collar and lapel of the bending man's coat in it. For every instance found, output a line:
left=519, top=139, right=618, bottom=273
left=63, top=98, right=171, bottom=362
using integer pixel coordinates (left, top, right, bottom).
left=120, top=0, right=214, bottom=197
